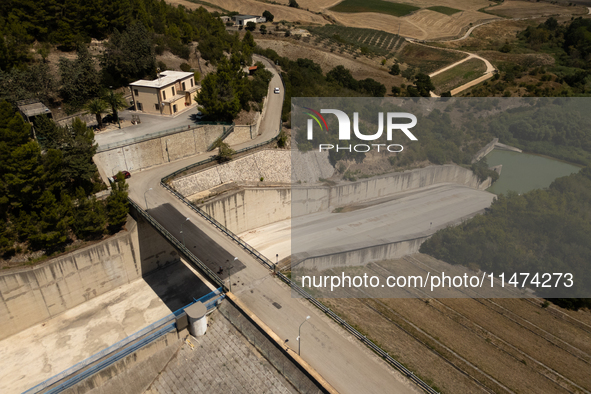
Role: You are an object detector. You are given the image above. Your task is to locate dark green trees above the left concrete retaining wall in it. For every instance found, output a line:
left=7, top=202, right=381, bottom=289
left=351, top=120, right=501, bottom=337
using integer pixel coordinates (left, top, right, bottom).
left=0, top=101, right=128, bottom=258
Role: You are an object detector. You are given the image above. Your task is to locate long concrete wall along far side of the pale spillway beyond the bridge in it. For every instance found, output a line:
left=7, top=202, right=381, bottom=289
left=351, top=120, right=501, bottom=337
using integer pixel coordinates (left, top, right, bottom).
left=197, top=165, right=490, bottom=234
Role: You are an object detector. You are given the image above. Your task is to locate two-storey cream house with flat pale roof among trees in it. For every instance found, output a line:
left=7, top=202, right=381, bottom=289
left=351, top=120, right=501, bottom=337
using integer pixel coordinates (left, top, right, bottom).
left=129, top=71, right=199, bottom=115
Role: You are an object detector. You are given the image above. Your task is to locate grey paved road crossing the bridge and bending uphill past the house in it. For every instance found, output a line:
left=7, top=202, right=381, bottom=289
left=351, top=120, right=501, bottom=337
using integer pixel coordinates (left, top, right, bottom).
left=129, top=57, right=419, bottom=394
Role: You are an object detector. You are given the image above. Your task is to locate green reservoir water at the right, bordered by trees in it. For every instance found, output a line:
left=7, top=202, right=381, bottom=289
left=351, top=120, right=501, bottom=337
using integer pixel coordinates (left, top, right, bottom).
left=486, top=149, right=580, bottom=194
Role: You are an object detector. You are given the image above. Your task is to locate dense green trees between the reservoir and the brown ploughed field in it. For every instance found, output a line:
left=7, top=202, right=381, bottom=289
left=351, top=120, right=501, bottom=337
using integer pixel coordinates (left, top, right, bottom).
left=420, top=167, right=591, bottom=310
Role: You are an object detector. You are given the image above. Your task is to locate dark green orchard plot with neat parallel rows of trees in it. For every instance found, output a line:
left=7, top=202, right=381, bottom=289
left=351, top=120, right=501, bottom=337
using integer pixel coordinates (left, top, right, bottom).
left=306, top=25, right=404, bottom=56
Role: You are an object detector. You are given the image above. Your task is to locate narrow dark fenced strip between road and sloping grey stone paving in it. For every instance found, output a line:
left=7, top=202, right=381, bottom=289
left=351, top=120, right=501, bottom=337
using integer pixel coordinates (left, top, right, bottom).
left=219, top=302, right=324, bottom=394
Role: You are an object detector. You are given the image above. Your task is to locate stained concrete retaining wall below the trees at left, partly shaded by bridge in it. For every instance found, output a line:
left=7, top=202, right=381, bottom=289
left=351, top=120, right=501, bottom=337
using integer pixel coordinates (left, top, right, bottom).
left=0, top=214, right=179, bottom=340
